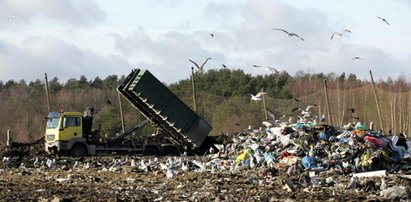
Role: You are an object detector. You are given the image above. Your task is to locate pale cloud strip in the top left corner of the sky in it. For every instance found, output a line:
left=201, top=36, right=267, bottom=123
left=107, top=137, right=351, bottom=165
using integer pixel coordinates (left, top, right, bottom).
left=0, top=0, right=106, bottom=25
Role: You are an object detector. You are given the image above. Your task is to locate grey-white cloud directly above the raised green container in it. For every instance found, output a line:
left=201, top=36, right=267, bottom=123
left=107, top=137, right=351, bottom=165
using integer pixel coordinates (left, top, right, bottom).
left=114, top=28, right=224, bottom=83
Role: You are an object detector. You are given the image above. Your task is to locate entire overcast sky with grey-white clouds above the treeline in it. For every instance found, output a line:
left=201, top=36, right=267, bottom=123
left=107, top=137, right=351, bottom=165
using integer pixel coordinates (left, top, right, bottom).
left=0, top=0, right=411, bottom=84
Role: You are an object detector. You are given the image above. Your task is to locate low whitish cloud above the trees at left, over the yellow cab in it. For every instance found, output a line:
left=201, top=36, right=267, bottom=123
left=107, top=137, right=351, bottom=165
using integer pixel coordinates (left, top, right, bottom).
left=0, top=37, right=131, bottom=81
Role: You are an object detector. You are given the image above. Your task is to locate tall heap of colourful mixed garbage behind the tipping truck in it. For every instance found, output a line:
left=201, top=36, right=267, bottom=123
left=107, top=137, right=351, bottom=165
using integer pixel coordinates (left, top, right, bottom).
left=225, top=122, right=411, bottom=175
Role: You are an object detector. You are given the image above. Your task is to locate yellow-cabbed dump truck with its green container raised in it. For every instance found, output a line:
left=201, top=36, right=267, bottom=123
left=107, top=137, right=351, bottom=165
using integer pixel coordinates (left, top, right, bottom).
left=45, top=69, right=218, bottom=156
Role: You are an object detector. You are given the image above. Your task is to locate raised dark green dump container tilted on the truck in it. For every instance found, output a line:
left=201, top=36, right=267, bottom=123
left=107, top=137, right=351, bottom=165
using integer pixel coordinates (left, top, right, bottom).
left=117, top=69, right=211, bottom=148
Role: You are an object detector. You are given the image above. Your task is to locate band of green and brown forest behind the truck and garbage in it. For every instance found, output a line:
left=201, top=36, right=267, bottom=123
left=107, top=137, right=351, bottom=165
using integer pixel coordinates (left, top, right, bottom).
left=0, top=68, right=411, bottom=143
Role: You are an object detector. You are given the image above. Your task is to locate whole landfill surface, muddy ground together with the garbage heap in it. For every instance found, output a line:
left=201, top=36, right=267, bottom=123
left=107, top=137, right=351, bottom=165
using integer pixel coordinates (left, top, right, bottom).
left=0, top=118, right=411, bottom=201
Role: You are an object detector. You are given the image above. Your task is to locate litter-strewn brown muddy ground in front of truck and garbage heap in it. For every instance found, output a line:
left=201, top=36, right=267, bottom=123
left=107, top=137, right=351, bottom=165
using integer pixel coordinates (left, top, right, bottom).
left=0, top=141, right=411, bottom=201
